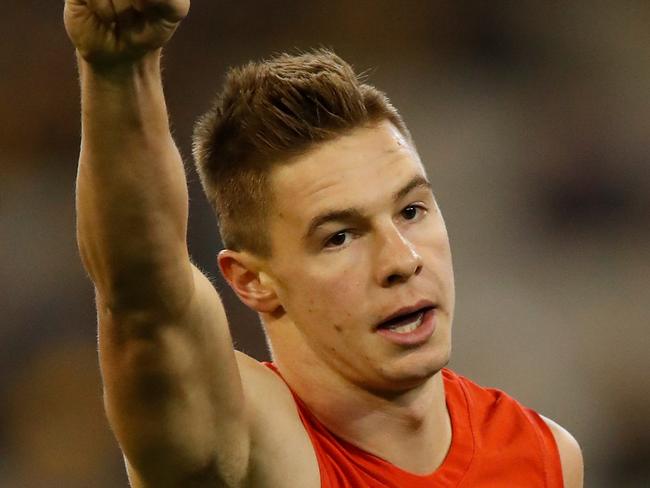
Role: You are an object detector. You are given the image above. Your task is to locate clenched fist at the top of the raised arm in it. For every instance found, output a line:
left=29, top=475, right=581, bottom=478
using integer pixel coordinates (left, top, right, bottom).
left=64, top=0, right=190, bottom=66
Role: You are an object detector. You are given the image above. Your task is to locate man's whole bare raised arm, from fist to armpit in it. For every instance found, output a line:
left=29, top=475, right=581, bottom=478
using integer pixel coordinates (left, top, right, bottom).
left=64, top=0, right=249, bottom=487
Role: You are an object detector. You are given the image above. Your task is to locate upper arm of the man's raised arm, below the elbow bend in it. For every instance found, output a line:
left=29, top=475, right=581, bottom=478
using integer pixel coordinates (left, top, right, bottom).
left=98, top=266, right=250, bottom=487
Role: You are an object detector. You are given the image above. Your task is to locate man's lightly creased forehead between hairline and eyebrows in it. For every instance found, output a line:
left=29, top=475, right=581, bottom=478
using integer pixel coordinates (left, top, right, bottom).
left=270, top=121, right=425, bottom=224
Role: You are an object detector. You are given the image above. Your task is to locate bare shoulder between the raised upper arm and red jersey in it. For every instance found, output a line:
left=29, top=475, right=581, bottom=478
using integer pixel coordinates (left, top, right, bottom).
left=235, top=352, right=320, bottom=488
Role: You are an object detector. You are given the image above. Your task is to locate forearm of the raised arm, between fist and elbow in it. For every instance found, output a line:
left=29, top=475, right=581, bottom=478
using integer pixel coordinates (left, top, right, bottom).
left=77, top=52, right=191, bottom=309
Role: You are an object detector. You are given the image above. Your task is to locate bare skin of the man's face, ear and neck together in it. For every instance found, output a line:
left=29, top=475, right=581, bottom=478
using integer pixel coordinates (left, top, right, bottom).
left=220, top=122, right=454, bottom=474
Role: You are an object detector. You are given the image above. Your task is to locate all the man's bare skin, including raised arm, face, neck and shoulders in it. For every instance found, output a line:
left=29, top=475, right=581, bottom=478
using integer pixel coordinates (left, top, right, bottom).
left=64, top=0, right=582, bottom=488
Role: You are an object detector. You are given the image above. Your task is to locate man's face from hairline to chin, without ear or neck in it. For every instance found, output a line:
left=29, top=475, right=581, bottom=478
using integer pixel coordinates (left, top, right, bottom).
left=266, top=122, right=454, bottom=390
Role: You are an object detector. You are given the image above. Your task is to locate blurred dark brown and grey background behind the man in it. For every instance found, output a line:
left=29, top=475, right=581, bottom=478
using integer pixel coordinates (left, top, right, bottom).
left=0, top=0, right=650, bottom=488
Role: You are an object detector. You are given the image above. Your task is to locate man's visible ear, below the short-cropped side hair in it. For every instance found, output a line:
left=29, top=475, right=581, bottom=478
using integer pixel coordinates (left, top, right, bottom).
left=217, top=249, right=281, bottom=313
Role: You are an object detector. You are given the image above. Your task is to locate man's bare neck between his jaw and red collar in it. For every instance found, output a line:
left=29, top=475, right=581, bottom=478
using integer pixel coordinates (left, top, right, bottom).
left=268, top=314, right=451, bottom=474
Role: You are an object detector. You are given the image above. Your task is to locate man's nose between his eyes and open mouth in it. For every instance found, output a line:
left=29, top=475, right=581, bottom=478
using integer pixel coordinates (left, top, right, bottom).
left=376, top=225, right=422, bottom=288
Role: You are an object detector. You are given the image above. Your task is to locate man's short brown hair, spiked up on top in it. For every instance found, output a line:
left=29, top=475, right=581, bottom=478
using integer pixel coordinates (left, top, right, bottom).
left=193, top=49, right=411, bottom=256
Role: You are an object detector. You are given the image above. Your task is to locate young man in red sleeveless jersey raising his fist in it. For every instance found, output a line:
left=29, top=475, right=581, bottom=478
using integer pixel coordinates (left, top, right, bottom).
left=65, top=0, right=582, bottom=488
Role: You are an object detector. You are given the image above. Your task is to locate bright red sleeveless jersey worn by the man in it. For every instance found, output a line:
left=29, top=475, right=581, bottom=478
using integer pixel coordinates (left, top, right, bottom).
left=265, top=363, right=563, bottom=488
